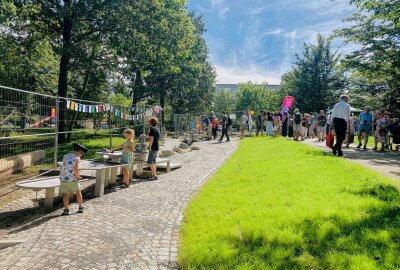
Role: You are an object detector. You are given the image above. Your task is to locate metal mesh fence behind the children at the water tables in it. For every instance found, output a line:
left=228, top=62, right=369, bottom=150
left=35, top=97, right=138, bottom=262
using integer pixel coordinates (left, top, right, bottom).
left=0, top=86, right=162, bottom=189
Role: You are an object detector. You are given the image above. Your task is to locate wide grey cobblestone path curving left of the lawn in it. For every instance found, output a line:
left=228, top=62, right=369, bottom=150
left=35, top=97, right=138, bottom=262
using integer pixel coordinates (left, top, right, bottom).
left=0, top=140, right=238, bottom=270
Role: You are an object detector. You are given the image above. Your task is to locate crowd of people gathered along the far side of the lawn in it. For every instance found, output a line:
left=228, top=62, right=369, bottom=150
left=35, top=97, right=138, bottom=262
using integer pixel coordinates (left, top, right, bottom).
left=197, top=98, right=400, bottom=156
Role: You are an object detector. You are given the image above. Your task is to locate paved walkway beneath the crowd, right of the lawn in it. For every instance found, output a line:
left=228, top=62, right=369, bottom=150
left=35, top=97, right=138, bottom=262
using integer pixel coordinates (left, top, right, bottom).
left=303, top=139, right=400, bottom=180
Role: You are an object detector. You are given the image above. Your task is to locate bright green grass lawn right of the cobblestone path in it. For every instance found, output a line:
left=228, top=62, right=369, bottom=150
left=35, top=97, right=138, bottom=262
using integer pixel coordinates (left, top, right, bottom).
left=179, top=138, right=400, bottom=269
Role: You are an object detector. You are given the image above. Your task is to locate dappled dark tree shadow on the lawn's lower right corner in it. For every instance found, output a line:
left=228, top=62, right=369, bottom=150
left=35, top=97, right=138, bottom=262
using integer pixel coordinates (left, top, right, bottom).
left=212, top=184, right=400, bottom=269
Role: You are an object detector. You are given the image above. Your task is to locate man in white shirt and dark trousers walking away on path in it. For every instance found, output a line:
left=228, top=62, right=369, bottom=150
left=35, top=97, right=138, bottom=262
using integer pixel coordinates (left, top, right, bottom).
left=332, top=95, right=350, bottom=156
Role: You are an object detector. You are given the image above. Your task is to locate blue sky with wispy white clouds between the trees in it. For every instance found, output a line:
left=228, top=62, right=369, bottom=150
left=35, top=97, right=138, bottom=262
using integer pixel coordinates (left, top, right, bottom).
left=188, top=0, right=356, bottom=84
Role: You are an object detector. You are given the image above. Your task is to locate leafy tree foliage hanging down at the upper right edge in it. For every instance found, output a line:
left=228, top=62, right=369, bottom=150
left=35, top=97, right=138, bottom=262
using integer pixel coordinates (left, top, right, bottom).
left=335, top=0, right=400, bottom=113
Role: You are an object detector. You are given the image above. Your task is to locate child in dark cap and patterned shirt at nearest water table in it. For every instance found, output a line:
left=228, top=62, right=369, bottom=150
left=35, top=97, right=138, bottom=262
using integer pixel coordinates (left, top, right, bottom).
left=60, top=143, right=88, bottom=216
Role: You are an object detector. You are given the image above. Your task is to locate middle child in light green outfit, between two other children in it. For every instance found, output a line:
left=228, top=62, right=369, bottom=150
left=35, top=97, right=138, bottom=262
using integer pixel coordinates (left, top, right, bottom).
left=111, top=128, right=135, bottom=188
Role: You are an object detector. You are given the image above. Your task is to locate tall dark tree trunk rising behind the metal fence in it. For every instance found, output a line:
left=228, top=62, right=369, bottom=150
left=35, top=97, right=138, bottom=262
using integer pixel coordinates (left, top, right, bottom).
left=57, top=0, right=72, bottom=144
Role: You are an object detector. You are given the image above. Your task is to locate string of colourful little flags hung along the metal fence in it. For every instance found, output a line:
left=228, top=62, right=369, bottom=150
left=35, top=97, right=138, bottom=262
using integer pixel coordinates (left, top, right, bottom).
left=67, top=100, right=162, bottom=121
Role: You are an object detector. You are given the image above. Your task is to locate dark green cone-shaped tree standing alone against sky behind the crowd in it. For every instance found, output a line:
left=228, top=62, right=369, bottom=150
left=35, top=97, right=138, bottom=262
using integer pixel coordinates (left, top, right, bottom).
left=282, top=34, right=346, bottom=112
